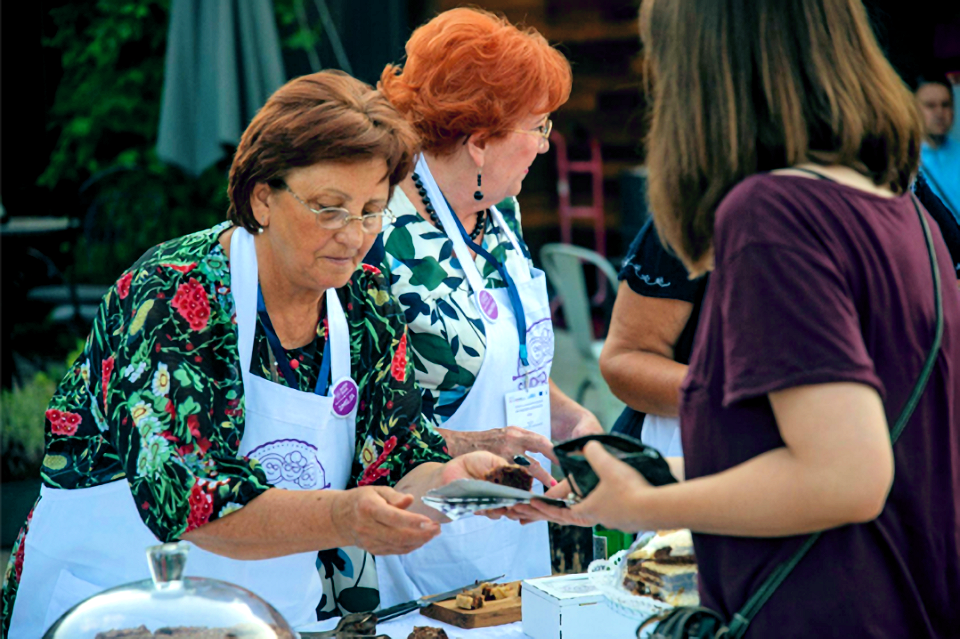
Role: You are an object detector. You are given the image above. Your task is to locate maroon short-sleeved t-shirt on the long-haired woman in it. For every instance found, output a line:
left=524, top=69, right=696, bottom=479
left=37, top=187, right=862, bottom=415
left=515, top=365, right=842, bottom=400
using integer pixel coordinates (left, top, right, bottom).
left=680, top=175, right=960, bottom=639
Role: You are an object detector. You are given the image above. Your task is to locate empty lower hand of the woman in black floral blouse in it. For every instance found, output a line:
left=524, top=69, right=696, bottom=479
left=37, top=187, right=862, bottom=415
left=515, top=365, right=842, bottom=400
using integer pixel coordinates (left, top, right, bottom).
left=330, top=486, right=440, bottom=555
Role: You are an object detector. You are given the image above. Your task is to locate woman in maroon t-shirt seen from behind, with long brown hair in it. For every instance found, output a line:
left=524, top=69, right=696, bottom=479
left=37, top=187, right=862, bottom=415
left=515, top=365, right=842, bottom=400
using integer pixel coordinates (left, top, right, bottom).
left=514, top=0, right=960, bottom=638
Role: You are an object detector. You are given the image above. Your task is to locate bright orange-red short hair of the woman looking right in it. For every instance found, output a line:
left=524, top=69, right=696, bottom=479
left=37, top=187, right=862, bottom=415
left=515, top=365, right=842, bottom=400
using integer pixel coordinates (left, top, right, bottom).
left=378, top=8, right=573, bottom=154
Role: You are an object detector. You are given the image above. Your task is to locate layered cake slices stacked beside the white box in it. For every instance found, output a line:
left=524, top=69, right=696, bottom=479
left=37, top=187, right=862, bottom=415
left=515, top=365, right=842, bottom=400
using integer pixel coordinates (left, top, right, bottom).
left=623, top=530, right=700, bottom=606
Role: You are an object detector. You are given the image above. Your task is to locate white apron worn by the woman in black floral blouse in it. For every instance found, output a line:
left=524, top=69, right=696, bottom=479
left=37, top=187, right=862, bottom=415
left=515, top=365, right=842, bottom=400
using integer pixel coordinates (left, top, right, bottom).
left=9, top=228, right=356, bottom=639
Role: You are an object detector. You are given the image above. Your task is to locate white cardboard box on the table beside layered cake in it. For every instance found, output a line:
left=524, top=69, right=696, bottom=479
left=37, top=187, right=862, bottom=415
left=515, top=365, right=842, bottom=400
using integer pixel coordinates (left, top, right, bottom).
left=520, top=574, right=646, bottom=639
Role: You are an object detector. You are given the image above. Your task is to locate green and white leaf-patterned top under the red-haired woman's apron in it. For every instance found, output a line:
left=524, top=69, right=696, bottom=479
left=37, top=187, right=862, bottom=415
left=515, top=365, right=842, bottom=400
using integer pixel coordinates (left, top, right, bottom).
left=381, top=188, right=530, bottom=426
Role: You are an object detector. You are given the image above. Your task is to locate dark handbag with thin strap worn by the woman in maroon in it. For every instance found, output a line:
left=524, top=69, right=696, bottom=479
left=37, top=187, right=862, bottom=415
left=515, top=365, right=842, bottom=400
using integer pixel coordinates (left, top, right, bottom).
left=637, top=196, right=943, bottom=639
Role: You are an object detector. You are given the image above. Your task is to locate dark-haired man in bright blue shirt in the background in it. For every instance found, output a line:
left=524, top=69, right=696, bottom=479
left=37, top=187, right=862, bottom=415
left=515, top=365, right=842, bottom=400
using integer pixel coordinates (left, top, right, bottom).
left=916, top=77, right=960, bottom=222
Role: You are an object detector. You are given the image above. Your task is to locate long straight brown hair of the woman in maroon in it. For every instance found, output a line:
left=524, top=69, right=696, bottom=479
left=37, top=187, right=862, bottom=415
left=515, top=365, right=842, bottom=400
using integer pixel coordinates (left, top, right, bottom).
left=640, top=0, right=922, bottom=274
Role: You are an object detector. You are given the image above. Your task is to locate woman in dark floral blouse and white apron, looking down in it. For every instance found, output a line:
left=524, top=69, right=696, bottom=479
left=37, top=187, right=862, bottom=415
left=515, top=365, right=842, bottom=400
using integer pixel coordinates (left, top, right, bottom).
left=0, top=72, right=505, bottom=639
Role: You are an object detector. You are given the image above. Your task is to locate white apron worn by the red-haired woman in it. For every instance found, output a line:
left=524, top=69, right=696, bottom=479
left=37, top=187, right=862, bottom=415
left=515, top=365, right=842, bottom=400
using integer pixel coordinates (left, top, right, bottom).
left=377, top=156, right=553, bottom=607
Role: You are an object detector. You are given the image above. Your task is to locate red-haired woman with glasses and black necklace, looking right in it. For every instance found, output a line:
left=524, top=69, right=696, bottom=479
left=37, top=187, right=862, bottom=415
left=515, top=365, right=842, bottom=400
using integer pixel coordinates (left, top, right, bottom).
left=377, top=8, right=602, bottom=605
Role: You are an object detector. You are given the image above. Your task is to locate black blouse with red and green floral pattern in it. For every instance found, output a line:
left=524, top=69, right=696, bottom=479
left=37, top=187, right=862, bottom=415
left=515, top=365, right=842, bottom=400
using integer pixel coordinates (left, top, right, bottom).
left=0, top=223, right=449, bottom=637
